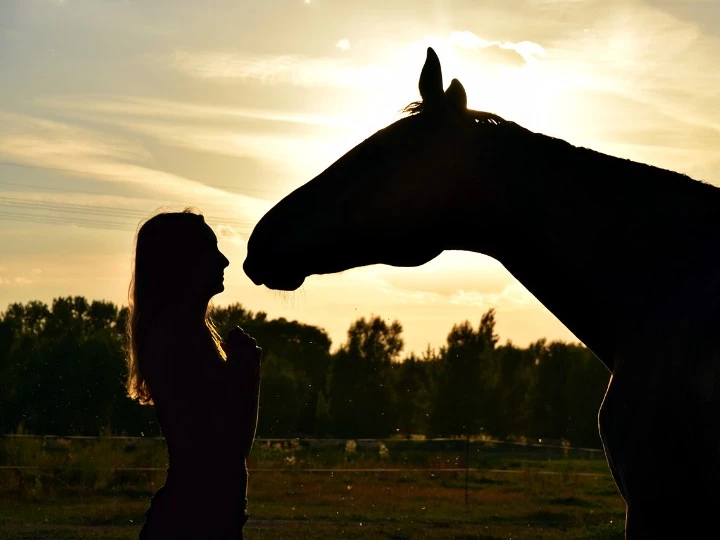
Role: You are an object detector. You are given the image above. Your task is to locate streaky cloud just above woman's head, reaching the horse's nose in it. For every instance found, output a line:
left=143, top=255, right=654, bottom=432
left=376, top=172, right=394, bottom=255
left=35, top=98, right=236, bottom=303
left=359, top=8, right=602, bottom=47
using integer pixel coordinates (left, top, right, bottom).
left=0, top=111, right=269, bottom=229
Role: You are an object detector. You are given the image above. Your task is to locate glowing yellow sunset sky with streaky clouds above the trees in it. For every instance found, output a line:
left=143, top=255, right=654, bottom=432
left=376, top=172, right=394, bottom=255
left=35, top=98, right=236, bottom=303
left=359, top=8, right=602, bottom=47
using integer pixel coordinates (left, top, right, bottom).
left=0, top=0, right=720, bottom=354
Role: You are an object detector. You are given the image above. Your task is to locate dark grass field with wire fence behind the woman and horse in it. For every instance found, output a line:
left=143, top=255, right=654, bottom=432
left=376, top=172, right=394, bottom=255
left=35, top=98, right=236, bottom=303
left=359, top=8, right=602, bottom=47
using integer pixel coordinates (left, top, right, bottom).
left=0, top=439, right=624, bottom=540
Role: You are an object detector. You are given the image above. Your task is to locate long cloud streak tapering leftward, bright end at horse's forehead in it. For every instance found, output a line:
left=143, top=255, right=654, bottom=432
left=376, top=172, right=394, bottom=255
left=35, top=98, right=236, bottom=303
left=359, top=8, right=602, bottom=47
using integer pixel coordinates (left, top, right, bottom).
left=35, top=96, right=355, bottom=184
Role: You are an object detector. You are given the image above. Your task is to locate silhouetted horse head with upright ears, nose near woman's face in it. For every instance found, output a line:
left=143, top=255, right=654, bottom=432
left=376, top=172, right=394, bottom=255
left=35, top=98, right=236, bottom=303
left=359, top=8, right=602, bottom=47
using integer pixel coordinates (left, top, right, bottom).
left=243, top=48, right=503, bottom=290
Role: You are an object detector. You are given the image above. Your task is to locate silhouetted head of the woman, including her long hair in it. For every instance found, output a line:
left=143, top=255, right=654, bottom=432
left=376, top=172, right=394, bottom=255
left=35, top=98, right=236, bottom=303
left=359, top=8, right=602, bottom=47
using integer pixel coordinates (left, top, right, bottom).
left=128, top=209, right=229, bottom=402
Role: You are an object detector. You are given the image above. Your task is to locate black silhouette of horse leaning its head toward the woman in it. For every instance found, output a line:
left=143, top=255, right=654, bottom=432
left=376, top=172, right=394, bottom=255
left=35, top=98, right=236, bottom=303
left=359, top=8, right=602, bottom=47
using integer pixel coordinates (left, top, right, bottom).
left=244, top=49, right=720, bottom=539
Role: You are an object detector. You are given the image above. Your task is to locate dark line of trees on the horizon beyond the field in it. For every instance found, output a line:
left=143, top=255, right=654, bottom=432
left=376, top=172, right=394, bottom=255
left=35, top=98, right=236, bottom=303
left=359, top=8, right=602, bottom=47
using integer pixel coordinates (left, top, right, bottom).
left=0, top=296, right=609, bottom=447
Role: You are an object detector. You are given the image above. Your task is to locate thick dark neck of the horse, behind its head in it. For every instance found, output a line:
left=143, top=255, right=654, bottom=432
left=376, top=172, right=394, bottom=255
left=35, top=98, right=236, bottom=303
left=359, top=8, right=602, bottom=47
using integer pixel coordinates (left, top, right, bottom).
left=455, top=123, right=720, bottom=370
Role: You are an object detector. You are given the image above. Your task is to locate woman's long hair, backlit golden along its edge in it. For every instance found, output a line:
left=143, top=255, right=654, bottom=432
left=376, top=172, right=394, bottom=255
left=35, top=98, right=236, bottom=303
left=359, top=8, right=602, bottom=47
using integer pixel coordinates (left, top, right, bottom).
left=126, top=208, right=225, bottom=404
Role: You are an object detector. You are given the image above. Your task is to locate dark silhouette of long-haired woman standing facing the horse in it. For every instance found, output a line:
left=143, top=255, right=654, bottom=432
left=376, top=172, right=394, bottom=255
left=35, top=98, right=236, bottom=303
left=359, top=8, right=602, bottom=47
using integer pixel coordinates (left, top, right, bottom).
left=128, top=210, right=262, bottom=540
